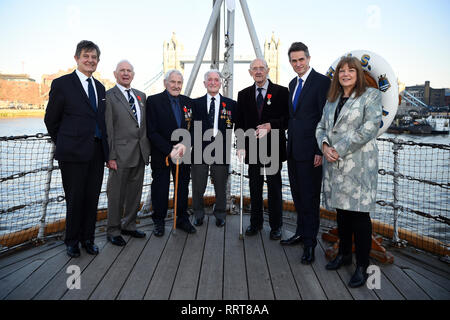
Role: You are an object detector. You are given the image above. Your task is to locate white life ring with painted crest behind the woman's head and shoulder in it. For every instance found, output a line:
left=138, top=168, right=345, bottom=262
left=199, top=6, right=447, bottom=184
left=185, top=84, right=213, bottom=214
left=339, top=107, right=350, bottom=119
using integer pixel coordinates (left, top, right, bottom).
left=326, top=50, right=399, bottom=136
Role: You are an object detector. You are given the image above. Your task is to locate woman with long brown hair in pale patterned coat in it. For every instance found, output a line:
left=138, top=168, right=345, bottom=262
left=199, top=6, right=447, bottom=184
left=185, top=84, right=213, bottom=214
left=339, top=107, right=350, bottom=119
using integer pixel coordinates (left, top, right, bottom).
left=316, top=57, right=382, bottom=287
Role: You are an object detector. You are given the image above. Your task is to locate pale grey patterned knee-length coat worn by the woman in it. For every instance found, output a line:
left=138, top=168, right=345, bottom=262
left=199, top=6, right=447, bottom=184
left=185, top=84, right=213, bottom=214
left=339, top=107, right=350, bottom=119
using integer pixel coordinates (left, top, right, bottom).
left=316, top=88, right=382, bottom=212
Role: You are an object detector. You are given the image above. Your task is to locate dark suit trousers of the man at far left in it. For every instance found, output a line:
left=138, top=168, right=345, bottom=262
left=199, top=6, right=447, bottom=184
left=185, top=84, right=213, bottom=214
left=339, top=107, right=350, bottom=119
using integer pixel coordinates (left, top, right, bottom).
left=59, top=141, right=105, bottom=246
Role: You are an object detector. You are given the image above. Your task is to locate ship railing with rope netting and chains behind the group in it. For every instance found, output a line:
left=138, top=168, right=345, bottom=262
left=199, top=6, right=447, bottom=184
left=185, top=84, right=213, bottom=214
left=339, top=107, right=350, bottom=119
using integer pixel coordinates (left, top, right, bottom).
left=0, top=133, right=450, bottom=257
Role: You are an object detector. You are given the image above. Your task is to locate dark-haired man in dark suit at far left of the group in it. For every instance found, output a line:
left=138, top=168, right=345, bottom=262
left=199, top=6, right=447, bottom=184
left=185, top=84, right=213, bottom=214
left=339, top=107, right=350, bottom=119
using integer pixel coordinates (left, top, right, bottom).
left=44, top=40, right=109, bottom=257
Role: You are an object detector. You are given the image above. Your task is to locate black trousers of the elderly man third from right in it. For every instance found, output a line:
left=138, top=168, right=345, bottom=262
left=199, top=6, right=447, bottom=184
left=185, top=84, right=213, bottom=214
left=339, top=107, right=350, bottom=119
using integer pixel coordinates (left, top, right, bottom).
left=248, top=162, right=283, bottom=230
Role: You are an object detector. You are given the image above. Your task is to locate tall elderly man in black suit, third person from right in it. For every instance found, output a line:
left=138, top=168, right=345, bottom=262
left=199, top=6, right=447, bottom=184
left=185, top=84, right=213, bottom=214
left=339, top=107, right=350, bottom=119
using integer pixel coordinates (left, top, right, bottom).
left=235, top=59, right=289, bottom=240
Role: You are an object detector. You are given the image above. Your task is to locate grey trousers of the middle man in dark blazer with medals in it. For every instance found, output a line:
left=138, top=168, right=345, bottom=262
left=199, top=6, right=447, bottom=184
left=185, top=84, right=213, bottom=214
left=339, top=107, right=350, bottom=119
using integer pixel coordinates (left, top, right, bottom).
left=191, top=164, right=228, bottom=219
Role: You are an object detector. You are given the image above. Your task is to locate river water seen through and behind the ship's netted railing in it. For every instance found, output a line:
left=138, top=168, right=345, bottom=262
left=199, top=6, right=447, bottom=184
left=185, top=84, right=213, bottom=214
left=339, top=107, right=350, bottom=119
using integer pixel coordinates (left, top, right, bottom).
left=0, top=118, right=450, bottom=243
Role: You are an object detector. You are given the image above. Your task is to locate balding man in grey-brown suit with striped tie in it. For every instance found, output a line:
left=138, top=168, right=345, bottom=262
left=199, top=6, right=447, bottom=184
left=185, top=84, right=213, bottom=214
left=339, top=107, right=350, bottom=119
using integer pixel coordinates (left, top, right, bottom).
left=105, top=60, right=150, bottom=246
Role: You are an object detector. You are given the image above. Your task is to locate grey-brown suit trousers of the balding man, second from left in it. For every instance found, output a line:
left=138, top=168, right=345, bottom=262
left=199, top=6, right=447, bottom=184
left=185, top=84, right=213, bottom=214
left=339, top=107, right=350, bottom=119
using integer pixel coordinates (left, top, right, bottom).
left=106, top=161, right=145, bottom=237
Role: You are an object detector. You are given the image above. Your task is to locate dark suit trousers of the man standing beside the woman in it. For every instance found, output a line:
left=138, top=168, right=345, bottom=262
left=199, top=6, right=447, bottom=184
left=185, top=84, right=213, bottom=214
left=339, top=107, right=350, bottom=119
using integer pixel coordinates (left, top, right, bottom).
left=288, top=158, right=322, bottom=247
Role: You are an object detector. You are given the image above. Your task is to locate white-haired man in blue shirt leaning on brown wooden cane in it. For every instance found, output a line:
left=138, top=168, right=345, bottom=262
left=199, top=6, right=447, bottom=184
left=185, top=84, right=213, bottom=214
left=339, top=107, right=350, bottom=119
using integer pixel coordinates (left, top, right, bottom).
left=147, top=70, right=196, bottom=237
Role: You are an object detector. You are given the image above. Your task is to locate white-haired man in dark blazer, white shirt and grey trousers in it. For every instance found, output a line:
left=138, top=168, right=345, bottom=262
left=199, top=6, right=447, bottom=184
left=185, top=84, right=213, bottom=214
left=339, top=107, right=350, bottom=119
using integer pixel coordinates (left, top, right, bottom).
left=191, top=69, right=236, bottom=227
